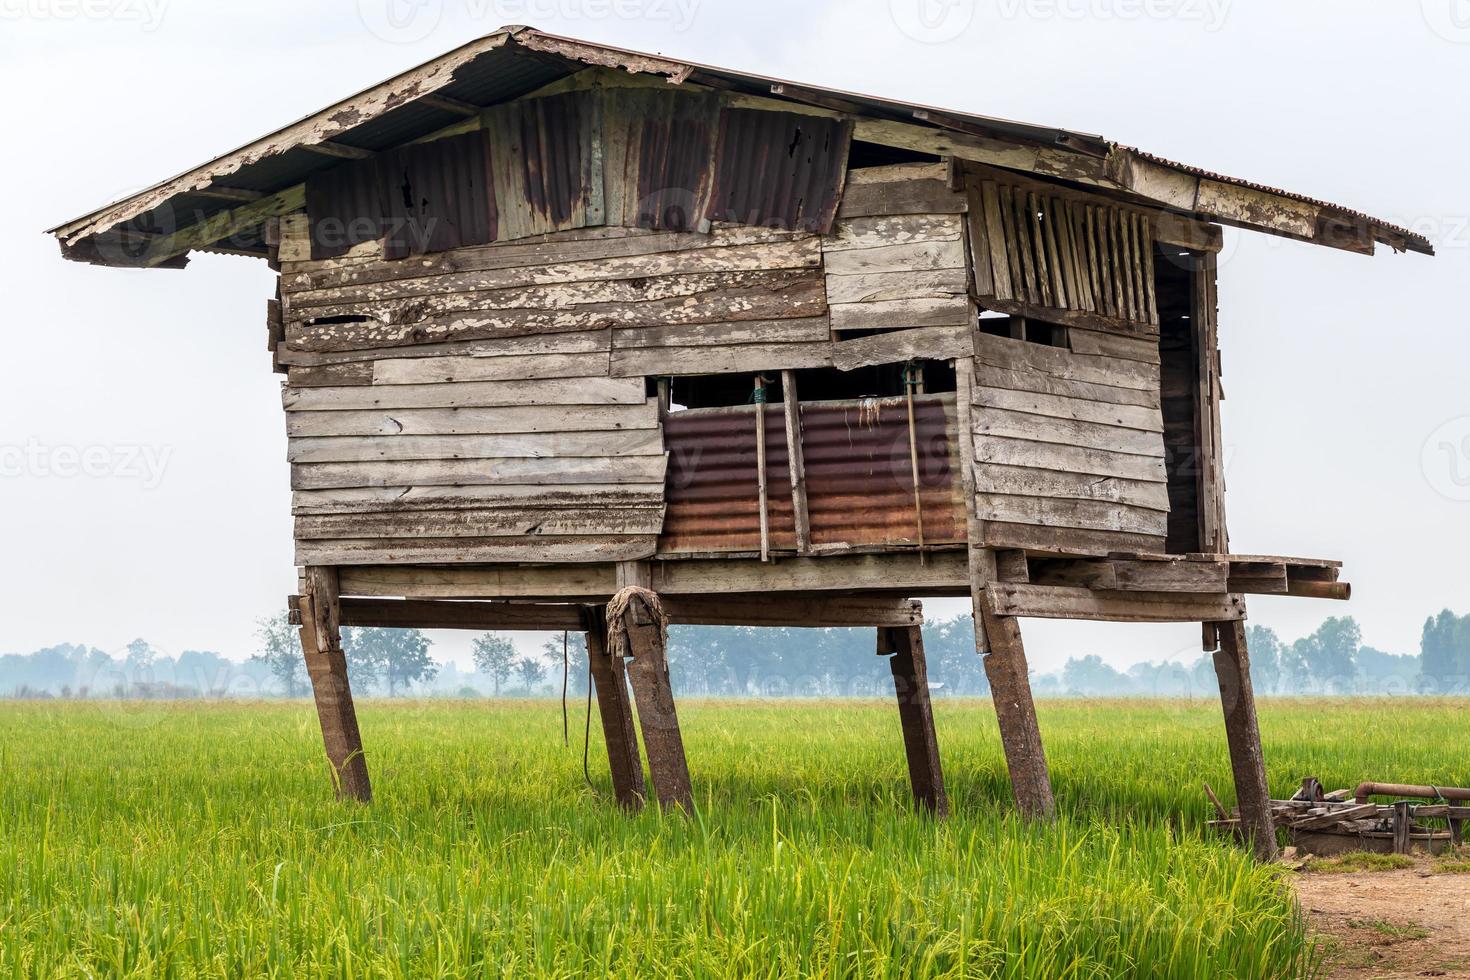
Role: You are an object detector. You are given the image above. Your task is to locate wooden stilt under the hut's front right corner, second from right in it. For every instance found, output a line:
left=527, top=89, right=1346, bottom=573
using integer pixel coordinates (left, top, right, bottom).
left=976, top=598, right=1057, bottom=820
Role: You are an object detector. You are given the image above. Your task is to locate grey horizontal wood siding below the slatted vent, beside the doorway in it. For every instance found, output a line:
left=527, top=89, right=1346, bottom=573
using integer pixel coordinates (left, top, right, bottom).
left=969, top=334, right=1169, bottom=554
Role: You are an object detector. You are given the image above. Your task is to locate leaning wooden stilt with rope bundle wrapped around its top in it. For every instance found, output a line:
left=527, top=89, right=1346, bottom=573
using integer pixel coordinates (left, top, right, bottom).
left=614, top=594, right=694, bottom=813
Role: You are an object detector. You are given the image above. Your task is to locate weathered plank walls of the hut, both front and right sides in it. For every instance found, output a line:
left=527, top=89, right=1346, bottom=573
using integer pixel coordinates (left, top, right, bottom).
left=275, top=70, right=1193, bottom=575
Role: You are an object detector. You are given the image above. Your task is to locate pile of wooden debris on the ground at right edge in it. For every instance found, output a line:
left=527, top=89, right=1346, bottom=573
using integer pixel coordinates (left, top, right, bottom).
left=1204, top=776, right=1470, bottom=855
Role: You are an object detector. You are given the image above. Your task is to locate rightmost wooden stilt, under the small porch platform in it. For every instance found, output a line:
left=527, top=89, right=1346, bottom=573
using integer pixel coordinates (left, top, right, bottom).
left=1214, top=620, right=1277, bottom=861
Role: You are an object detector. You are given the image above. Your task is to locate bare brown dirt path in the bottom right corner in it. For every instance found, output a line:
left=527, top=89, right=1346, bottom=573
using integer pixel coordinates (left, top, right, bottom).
left=1297, top=860, right=1470, bottom=980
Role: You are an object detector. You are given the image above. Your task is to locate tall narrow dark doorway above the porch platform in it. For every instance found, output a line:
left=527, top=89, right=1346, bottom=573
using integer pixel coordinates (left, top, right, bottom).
left=1154, top=242, right=1208, bottom=554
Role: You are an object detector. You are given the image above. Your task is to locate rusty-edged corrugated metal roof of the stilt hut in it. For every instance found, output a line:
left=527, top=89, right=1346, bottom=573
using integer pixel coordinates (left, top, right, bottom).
left=50, top=26, right=1433, bottom=264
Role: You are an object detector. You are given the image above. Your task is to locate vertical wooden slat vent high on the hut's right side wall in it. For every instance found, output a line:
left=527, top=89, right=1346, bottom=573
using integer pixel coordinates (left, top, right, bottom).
left=969, top=179, right=1158, bottom=334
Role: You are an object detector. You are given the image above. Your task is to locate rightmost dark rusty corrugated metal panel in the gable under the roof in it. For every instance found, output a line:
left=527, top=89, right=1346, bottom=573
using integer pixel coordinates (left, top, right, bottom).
left=709, top=109, right=853, bottom=235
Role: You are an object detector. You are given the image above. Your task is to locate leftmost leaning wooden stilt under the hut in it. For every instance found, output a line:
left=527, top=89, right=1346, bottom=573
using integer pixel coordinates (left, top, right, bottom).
left=301, top=566, right=372, bottom=804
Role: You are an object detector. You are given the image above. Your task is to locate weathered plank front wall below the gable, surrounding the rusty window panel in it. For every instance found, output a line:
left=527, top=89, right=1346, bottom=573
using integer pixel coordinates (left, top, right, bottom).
left=276, top=153, right=972, bottom=564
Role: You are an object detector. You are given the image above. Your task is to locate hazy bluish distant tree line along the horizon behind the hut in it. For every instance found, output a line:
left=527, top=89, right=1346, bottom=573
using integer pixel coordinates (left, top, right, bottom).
left=0, top=610, right=1470, bottom=699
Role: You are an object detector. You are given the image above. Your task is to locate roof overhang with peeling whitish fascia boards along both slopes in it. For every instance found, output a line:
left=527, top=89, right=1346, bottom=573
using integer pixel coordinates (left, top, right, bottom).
left=50, top=26, right=1435, bottom=267
